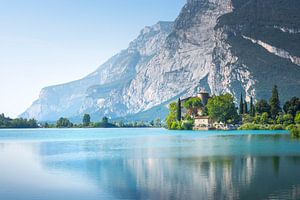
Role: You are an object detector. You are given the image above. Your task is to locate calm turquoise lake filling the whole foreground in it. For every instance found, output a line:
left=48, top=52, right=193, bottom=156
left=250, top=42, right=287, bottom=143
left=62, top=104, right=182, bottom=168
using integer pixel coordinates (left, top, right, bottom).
left=0, top=129, right=300, bottom=200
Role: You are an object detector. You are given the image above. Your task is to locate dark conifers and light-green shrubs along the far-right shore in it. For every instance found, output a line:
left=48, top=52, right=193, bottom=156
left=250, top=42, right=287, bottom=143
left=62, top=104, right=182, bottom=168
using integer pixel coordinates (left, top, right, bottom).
left=239, top=85, right=300, bottom=137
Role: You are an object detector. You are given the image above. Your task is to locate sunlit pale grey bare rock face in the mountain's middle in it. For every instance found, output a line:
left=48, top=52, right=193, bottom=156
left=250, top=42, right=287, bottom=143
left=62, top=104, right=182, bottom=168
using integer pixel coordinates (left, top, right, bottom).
left=125, top=0, right=232, bottom=112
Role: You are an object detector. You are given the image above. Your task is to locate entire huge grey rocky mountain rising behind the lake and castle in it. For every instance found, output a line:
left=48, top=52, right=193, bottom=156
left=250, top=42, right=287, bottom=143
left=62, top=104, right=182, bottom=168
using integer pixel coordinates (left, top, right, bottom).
left=21, top=0, right=300, bottom=121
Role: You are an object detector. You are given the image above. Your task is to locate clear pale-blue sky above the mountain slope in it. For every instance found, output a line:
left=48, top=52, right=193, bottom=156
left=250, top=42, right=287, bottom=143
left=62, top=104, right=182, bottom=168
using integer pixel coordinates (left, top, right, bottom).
left=0, top=0, right=185, bottom=117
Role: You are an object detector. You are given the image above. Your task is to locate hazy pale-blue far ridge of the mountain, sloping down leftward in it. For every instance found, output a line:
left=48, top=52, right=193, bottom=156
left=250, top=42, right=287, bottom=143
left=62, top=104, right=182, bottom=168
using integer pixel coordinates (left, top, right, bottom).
left=21, top=22, right=173, bottom=121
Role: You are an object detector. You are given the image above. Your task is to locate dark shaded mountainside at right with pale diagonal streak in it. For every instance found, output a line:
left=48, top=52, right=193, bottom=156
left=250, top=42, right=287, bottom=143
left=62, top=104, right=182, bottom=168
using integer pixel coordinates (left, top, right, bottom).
left=215, top=0, right=300, bottom=101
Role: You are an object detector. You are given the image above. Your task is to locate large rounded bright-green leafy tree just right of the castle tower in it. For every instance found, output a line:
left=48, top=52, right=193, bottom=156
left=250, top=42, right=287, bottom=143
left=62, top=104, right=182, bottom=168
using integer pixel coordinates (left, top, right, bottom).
left=207, top=94, right=238, bottom=123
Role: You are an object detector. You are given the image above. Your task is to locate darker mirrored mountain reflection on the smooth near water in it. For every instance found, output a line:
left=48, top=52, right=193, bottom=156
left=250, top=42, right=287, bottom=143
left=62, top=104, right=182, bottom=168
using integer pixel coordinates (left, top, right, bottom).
left=38, top=154, right=300, bottom=199
